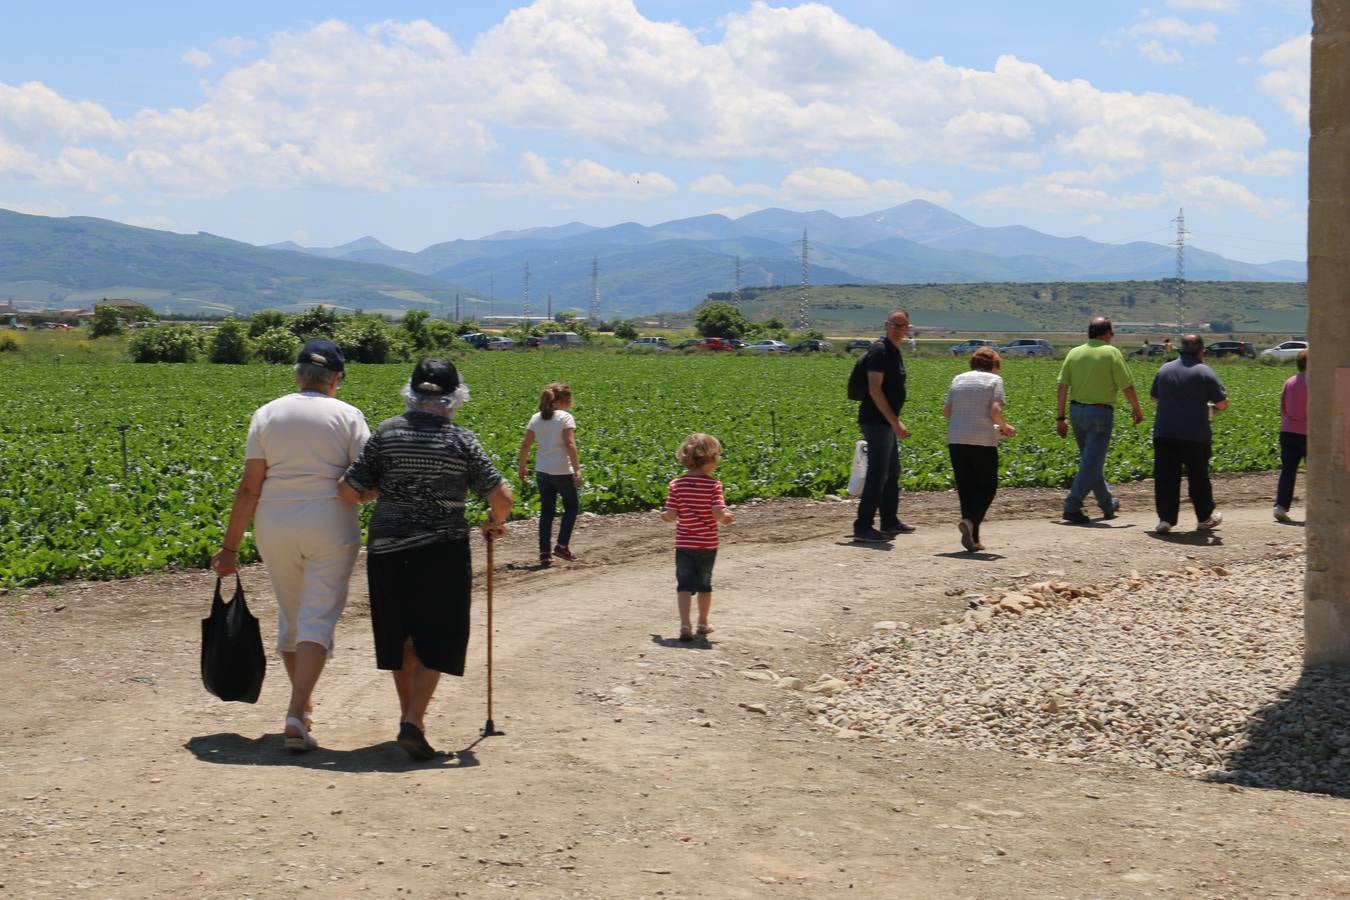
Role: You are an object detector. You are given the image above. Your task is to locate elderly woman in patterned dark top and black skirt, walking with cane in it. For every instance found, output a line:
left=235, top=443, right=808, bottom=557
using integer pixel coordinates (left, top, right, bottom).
left=339, top=359, right=513, bottom=760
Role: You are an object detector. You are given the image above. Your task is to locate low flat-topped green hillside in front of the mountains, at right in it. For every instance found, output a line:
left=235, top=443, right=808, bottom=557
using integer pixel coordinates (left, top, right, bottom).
left=713, top=281, right=1308, bottom=333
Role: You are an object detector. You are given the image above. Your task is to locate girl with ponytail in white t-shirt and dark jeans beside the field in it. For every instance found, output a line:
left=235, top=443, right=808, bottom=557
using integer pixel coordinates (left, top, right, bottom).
left=516, top=382, right=582, bottom=567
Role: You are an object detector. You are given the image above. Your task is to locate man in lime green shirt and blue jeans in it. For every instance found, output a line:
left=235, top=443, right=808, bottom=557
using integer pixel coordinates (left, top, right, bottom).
left=1054, top=316, right=1143, bottom=525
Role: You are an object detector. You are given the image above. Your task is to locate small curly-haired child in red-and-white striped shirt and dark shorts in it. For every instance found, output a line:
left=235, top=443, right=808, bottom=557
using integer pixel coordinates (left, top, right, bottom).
left=662, top=433, right=736, bottom=641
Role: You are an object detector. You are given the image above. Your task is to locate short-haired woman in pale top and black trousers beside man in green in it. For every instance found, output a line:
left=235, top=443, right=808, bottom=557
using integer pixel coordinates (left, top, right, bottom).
left=942, top=347, right=1017, bottom=552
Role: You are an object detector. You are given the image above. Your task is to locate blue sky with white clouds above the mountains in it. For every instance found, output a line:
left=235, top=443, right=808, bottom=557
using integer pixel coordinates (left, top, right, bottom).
left=0, top=0, right=1311, bottom=262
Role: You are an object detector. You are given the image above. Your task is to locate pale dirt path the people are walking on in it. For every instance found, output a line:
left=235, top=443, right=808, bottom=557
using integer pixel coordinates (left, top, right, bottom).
left=0, top=476, right=1350, bottom=897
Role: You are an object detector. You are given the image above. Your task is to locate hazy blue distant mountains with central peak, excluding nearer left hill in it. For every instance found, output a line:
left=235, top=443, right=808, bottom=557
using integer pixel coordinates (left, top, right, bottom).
left=271, top=200, right=1307, bottom=314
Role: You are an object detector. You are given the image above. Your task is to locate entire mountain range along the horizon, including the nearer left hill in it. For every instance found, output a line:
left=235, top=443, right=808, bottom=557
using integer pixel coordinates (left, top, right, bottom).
left=0, top=200, right=1305, bottom=318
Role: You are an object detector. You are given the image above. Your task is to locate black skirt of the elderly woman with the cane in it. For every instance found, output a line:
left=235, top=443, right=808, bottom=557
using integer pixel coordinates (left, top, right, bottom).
left=366, top=538, right=473, bottom=675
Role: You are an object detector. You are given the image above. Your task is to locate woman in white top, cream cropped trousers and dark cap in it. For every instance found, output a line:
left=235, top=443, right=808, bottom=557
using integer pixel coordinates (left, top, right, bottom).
left=211, top=339, right=370, bottom=752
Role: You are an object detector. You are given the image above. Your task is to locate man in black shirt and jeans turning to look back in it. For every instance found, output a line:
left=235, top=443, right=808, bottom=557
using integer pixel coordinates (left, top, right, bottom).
left=853, top=309, right=914, bottom=542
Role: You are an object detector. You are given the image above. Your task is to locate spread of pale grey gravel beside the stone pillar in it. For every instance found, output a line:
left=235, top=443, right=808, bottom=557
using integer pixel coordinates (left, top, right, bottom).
left=809, top=555, right=1350, bottom=793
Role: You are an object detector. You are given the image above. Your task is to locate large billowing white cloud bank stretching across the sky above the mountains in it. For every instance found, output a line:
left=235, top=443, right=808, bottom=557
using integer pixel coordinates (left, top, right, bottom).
left=0, top=0, right=1285, bottom=196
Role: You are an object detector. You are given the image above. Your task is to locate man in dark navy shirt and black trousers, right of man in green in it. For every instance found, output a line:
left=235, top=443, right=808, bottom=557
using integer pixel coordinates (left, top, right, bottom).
left=1149, top=335, right=1229, bottom=534
